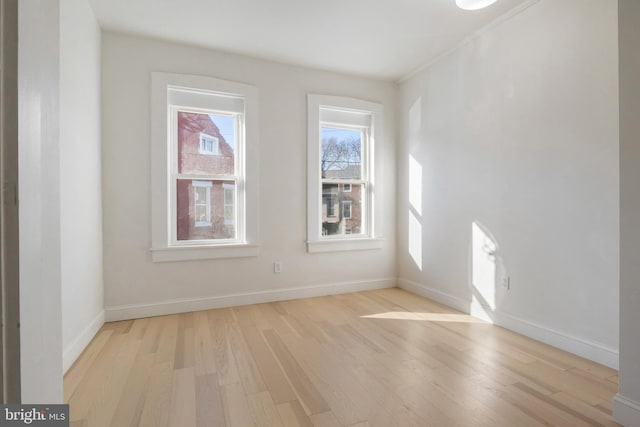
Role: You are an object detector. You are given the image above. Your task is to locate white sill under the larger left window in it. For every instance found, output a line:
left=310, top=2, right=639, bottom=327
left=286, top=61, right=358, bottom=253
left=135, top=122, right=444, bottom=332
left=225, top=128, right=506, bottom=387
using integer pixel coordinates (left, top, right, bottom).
left=151, top=244, right=260, bottom=262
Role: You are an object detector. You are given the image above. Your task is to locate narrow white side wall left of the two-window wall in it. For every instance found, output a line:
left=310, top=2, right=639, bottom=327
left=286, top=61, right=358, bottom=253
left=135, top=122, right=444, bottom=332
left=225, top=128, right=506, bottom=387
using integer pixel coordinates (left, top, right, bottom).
left=60, top=0, right=104, bottom=371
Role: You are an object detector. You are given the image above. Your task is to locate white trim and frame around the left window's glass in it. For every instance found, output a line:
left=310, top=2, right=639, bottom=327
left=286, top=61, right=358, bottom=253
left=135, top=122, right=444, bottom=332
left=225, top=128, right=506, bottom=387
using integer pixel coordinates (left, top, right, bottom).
left=150, top=72, right=259, bottom=262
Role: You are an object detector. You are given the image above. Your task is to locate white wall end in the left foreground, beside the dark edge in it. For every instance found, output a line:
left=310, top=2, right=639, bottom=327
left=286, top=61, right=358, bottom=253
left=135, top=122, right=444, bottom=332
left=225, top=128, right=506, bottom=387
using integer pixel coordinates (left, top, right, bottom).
left=18, top=0, right=62, bottom=403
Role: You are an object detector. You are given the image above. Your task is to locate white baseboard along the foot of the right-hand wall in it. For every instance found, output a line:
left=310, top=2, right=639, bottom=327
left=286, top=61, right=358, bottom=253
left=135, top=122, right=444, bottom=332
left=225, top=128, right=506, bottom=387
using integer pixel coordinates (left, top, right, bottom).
left=398, top=279, right=618, bottom=370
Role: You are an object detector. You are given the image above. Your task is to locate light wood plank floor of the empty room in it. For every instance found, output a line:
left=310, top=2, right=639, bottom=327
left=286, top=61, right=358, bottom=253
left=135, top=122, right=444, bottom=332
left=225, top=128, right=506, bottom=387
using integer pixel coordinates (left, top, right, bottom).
left=64, top=289, right=617, bottom=427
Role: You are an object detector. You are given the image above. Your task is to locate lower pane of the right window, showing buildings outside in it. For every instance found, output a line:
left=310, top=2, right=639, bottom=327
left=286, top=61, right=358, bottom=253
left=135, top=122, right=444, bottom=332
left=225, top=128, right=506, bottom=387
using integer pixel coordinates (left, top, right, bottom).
left=322, top=184, right=365, bottom=236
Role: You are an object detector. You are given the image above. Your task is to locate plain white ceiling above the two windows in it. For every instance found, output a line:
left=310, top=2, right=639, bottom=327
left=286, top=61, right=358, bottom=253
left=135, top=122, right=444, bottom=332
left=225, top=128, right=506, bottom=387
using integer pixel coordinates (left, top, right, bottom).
left=90, top=0, right=530, bottom=80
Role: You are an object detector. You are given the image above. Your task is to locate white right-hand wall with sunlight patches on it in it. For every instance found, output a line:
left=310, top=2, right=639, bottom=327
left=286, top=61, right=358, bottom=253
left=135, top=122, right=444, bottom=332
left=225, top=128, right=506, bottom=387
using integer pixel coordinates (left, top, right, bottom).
left=398, top=0, right=619, bottom=367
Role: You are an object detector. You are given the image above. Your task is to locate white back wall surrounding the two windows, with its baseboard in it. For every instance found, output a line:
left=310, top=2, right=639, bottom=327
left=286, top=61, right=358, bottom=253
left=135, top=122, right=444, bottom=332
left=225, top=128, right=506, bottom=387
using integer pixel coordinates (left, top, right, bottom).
left=102, top=33, right=396, bottom=319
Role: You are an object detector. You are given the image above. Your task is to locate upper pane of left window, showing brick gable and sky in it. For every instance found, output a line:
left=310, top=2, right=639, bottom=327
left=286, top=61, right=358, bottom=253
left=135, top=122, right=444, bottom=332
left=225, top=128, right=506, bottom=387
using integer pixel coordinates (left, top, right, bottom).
left=177, top=111, right=236, bottom=175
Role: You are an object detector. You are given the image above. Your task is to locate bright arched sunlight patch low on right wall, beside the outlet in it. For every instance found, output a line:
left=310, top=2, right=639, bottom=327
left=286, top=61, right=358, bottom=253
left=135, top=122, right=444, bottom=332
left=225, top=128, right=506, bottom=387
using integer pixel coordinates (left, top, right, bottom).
left=471, top=222, right=498, bottom=321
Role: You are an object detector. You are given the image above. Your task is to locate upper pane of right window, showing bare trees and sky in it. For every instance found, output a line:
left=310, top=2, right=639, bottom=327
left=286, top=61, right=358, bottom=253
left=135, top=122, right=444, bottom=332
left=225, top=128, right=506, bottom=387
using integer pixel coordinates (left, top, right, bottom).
left=320, top=126, right=362, bottom=179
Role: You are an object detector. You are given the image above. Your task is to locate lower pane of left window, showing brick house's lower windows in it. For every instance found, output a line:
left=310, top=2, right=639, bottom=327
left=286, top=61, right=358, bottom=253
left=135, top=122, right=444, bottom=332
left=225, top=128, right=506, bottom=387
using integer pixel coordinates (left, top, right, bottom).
left=176, top=179, right=236, bottom=240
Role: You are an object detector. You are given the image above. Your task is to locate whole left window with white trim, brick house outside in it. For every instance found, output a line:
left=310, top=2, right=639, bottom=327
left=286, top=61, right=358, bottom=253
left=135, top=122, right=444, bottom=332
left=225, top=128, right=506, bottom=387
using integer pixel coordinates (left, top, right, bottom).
left=151, top=73, right=258, bottom=262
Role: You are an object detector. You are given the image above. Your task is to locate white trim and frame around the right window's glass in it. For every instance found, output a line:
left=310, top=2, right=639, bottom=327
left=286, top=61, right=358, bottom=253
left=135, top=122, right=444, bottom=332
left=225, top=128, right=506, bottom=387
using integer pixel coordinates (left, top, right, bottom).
left=307, top=94, right=384, bottom=253
